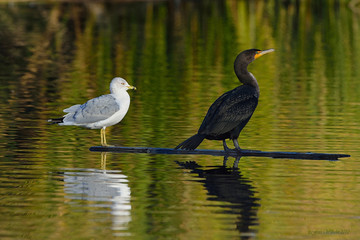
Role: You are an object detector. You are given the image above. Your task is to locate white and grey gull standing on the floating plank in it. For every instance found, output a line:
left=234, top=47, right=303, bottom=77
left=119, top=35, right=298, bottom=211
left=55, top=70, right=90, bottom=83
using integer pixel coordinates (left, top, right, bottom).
left=48, top=77, right=136, bottom=146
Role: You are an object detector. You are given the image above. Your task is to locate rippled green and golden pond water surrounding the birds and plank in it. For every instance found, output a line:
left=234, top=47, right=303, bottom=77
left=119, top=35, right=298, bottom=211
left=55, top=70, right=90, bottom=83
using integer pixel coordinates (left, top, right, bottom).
left=0, top=0, right=360, bottom=240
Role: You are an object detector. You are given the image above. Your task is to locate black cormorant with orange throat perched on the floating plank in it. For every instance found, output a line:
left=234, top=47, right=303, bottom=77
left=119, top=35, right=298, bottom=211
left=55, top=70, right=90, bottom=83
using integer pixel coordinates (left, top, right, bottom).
left=175, top=49, right=274, bottom=151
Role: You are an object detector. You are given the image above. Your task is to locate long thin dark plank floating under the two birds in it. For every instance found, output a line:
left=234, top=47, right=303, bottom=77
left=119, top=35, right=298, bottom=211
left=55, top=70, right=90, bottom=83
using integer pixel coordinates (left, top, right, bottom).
left=90, top=146, right=350, bottom=160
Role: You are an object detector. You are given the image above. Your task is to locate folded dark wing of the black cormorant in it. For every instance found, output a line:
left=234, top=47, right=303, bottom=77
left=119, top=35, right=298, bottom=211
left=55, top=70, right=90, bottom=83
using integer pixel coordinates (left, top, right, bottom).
left=199, top=85, right=258, bottom=135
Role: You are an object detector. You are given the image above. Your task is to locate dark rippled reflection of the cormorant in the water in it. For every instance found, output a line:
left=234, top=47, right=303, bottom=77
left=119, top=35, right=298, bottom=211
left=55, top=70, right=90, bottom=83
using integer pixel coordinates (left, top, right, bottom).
left=176, top=157, right=260, bottom=240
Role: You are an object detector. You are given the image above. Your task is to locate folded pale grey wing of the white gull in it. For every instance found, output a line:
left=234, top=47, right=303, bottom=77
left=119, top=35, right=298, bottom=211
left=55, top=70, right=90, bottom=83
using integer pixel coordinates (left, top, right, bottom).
left=72, top=94, right=120, bottom=124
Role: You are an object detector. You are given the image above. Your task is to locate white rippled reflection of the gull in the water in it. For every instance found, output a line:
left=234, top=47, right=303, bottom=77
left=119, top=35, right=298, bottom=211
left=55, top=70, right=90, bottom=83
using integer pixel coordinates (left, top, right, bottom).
left=64, top=154, right=131, bottom=231
